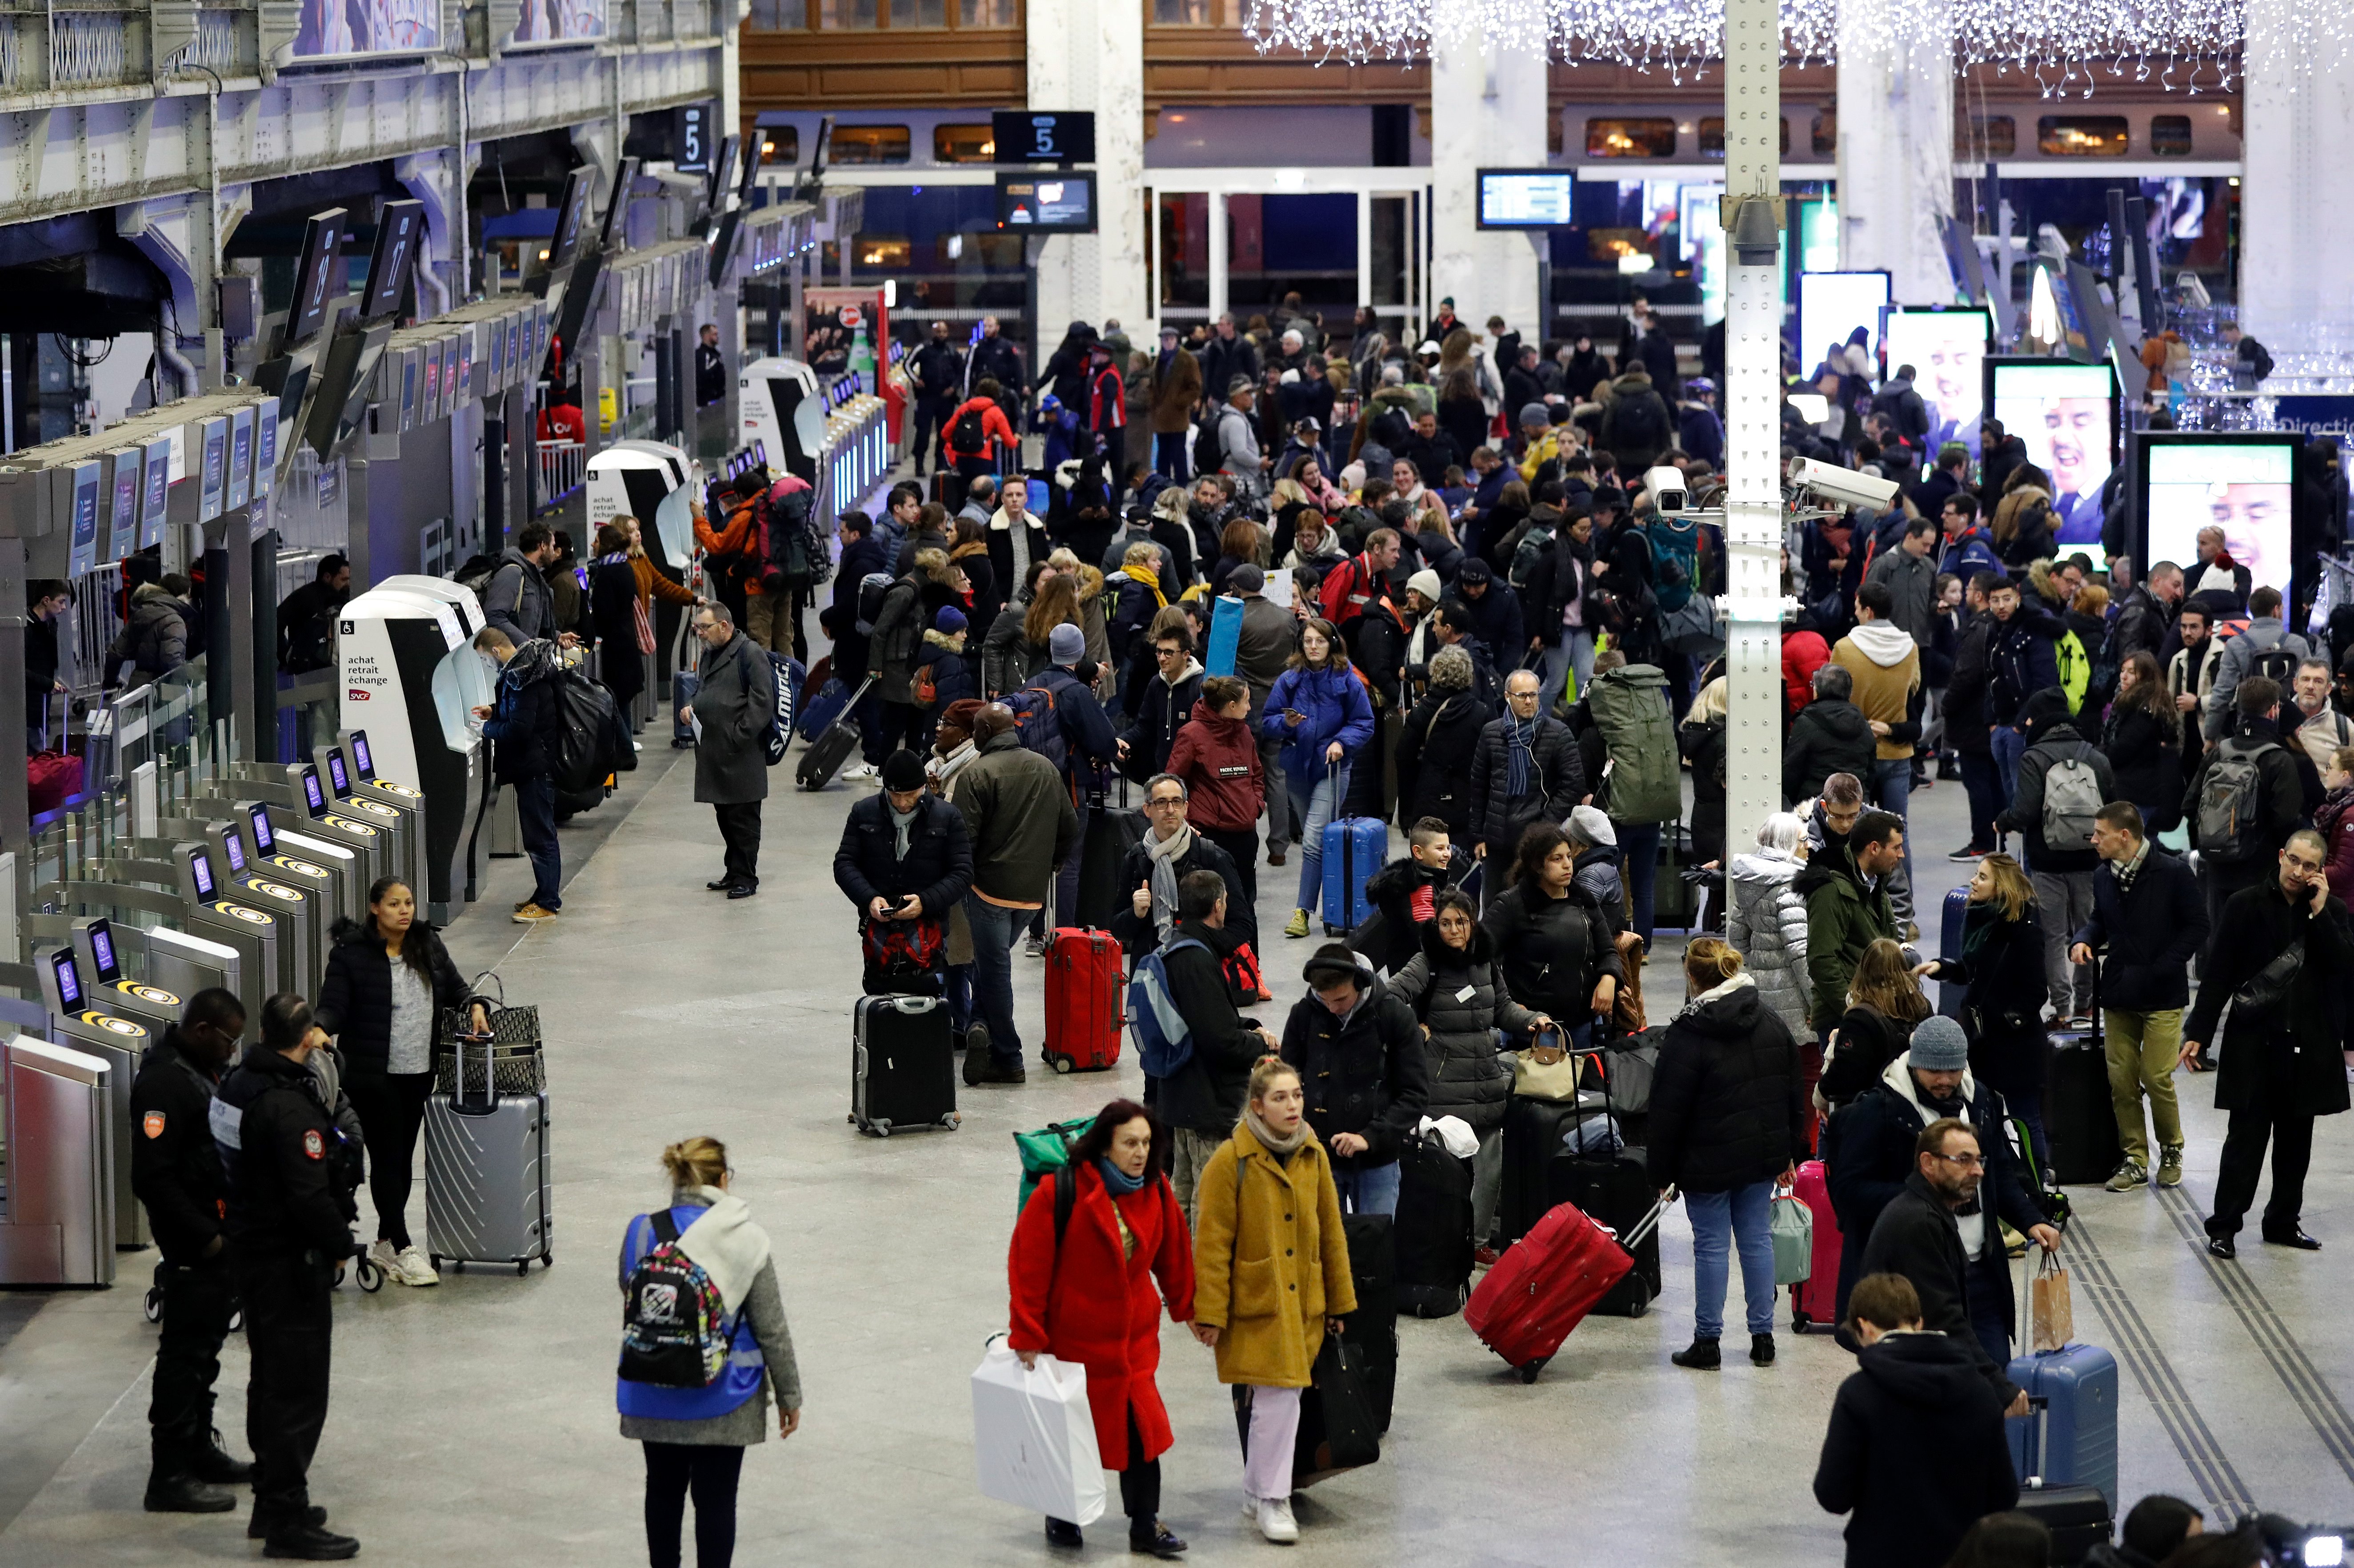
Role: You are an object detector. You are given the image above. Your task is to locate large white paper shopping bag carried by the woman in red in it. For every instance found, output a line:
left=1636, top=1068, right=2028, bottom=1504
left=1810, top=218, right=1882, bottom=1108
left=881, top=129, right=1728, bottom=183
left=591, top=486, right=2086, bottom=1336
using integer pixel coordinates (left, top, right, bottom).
left=972, top=1340, right=1104, bottom=1526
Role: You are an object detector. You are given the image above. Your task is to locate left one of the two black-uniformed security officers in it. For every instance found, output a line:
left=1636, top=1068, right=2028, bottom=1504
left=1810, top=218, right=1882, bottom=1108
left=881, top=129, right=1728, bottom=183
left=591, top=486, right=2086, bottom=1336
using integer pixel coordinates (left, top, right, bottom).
left=132, top=987, right=252, bottom=1514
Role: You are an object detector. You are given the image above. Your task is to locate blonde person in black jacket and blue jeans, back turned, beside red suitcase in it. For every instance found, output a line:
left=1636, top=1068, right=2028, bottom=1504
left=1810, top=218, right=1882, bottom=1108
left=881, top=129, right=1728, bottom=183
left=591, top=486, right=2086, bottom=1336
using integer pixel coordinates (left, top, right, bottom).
left=1645, top=937, right=1808, bottom=1368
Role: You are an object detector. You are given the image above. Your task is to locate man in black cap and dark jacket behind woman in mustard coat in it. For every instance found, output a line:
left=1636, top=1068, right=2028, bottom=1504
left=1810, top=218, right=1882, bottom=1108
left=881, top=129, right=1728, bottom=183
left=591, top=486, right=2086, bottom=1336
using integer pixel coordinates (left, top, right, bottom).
left=1283, top=942, right=1431, bottom=1215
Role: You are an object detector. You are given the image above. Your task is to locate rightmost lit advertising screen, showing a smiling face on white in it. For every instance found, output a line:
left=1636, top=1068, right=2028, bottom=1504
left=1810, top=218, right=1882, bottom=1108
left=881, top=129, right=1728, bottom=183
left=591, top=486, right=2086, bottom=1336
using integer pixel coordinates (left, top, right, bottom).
left=2140, top=431, right=2298, bottom=593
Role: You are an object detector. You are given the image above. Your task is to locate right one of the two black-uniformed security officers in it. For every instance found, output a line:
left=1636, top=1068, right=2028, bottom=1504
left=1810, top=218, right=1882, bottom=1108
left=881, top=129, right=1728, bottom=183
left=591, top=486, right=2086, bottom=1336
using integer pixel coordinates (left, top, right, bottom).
left=212, top=991, right=360, bottom=1561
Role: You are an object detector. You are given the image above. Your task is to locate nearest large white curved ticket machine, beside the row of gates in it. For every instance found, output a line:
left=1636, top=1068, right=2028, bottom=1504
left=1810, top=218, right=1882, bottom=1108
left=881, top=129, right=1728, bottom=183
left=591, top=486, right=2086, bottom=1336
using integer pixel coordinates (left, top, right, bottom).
left=336, top=577, right=494, bottom=923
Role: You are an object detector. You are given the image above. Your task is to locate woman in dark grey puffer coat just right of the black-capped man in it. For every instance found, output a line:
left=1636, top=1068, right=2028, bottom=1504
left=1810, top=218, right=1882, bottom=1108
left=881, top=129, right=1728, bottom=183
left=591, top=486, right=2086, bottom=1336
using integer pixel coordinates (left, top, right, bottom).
left=1389, top=890, right=1551, bottom=1248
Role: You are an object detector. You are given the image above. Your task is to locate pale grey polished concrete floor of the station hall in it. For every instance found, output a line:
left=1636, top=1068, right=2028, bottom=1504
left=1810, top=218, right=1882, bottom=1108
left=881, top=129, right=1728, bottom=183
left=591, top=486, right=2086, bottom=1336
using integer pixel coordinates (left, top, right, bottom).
left=0, top=701, right=2354, bottom=1568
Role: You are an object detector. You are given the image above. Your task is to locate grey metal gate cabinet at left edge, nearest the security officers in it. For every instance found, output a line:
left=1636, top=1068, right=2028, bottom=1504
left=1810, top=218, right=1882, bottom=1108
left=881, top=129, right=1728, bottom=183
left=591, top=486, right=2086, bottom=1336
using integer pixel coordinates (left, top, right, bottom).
left=0, top=1036, right=116, bottom=1285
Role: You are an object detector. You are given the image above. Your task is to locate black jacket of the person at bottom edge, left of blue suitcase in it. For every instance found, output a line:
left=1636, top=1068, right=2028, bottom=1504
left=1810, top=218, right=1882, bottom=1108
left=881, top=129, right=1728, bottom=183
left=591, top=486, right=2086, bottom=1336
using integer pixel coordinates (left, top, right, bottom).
left=1815, top=1330, right=2020, bottom=1568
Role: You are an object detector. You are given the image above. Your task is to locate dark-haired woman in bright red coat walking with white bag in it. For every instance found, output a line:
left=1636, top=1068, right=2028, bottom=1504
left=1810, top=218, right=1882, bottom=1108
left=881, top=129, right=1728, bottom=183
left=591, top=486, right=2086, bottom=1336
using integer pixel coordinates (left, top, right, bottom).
left=1005, top=1100, right=1193, bottom=1561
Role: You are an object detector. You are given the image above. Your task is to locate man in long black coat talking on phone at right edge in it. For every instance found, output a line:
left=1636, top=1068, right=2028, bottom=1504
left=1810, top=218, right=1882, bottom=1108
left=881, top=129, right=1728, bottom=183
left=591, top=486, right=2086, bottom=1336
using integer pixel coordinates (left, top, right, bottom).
left=2182, top=829, right=2354, bottom=1257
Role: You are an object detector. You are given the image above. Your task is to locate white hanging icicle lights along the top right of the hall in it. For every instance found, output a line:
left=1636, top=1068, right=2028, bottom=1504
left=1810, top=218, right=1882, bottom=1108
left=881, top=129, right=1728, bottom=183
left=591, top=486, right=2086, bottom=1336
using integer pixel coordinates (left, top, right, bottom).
left=1243, top=0, right=2354, bottom=96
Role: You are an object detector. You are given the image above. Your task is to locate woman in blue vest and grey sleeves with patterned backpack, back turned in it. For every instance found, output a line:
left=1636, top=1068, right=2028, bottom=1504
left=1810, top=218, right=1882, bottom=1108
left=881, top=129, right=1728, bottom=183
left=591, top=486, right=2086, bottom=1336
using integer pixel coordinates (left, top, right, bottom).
left=619, top=1137, right=801, bottom=1568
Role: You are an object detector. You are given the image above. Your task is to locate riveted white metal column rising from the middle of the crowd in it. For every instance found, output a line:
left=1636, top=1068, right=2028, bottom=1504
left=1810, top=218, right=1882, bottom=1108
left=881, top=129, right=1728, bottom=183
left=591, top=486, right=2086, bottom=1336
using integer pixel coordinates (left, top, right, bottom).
left=1725, top=0, right=1782, bottom=864
